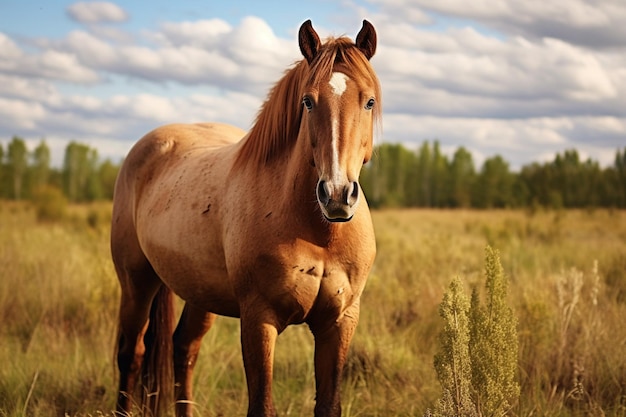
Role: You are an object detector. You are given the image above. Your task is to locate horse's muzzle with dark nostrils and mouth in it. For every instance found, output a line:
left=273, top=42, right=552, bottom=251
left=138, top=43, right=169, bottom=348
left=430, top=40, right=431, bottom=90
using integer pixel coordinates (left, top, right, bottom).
left=316, top=180, right=360, bottom=222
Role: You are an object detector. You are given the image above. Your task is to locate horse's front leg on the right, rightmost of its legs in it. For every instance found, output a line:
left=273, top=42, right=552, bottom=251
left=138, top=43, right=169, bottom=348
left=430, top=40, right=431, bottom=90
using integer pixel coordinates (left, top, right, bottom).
left=310, top=303, right=359, bottom=417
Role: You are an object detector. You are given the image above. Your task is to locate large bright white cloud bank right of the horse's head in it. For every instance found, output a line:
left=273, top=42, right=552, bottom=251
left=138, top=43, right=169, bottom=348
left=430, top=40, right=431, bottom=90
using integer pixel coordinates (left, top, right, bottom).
left=374, top=20, right=626, bottom=124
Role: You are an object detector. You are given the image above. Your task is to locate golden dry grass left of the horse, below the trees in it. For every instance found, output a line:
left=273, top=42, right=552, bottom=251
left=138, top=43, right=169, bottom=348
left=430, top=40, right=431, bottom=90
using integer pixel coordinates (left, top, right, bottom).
left=0, top=203, right=117, bottom=416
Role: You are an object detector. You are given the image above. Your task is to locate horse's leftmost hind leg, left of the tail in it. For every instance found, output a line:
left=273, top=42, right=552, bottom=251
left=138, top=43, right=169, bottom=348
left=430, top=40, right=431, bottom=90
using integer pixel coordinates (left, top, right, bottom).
left=116, top=268, right=161, bottom=415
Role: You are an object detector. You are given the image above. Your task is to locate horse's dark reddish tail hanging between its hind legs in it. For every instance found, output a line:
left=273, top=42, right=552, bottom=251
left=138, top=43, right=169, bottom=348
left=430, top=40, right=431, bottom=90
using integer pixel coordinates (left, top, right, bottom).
left=141, top=285, right=174, bottom=417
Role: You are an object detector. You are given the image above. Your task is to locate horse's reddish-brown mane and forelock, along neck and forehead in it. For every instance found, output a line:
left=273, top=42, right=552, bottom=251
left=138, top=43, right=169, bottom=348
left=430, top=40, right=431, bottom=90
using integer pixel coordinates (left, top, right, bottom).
left=234, top=37, right=382, bottom=168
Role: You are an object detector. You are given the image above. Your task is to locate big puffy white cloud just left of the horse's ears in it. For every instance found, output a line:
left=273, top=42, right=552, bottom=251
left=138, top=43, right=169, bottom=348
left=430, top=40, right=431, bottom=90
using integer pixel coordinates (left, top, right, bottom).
left=36, top=17, right=292, bottom=94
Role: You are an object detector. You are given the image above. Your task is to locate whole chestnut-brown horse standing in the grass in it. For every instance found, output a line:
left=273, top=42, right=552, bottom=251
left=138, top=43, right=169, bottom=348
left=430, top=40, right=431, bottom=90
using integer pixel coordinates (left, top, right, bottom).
left=111, top=21, right=381, bottom=416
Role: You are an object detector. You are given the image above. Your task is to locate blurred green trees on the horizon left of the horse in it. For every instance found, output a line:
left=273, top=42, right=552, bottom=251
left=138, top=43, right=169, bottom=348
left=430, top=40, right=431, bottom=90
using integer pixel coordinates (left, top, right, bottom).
left=0, top=136, right=120, bottom=203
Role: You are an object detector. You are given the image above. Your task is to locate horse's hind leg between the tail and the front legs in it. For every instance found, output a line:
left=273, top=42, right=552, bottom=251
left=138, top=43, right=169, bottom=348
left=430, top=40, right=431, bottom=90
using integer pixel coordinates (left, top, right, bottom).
left=174, top=303, right=215, bottom=417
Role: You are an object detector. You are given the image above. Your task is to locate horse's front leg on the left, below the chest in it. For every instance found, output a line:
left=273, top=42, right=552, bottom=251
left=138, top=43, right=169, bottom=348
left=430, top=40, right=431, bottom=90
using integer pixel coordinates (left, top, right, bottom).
left=241, top=306, right=278, bottom=417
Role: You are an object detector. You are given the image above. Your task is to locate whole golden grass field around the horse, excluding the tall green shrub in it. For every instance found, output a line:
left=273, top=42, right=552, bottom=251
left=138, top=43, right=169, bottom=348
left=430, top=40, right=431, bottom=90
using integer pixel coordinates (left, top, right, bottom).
left=0, top=202, right=626, bottom=417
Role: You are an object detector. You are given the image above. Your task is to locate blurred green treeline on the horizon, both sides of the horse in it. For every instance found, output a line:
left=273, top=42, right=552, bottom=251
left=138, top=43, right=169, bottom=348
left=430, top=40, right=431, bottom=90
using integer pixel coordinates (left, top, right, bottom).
left=0, top=136, right=626, bottom=208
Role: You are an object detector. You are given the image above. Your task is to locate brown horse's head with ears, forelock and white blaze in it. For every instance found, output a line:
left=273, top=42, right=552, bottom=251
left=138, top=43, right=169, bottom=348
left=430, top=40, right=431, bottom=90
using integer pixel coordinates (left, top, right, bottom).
left=299, top=21, right=380, bottom=222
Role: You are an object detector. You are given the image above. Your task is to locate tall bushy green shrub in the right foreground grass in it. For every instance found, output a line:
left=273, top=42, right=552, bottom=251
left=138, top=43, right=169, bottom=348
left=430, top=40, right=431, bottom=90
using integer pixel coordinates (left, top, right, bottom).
left=427, top=246, right=520, bottom=417
